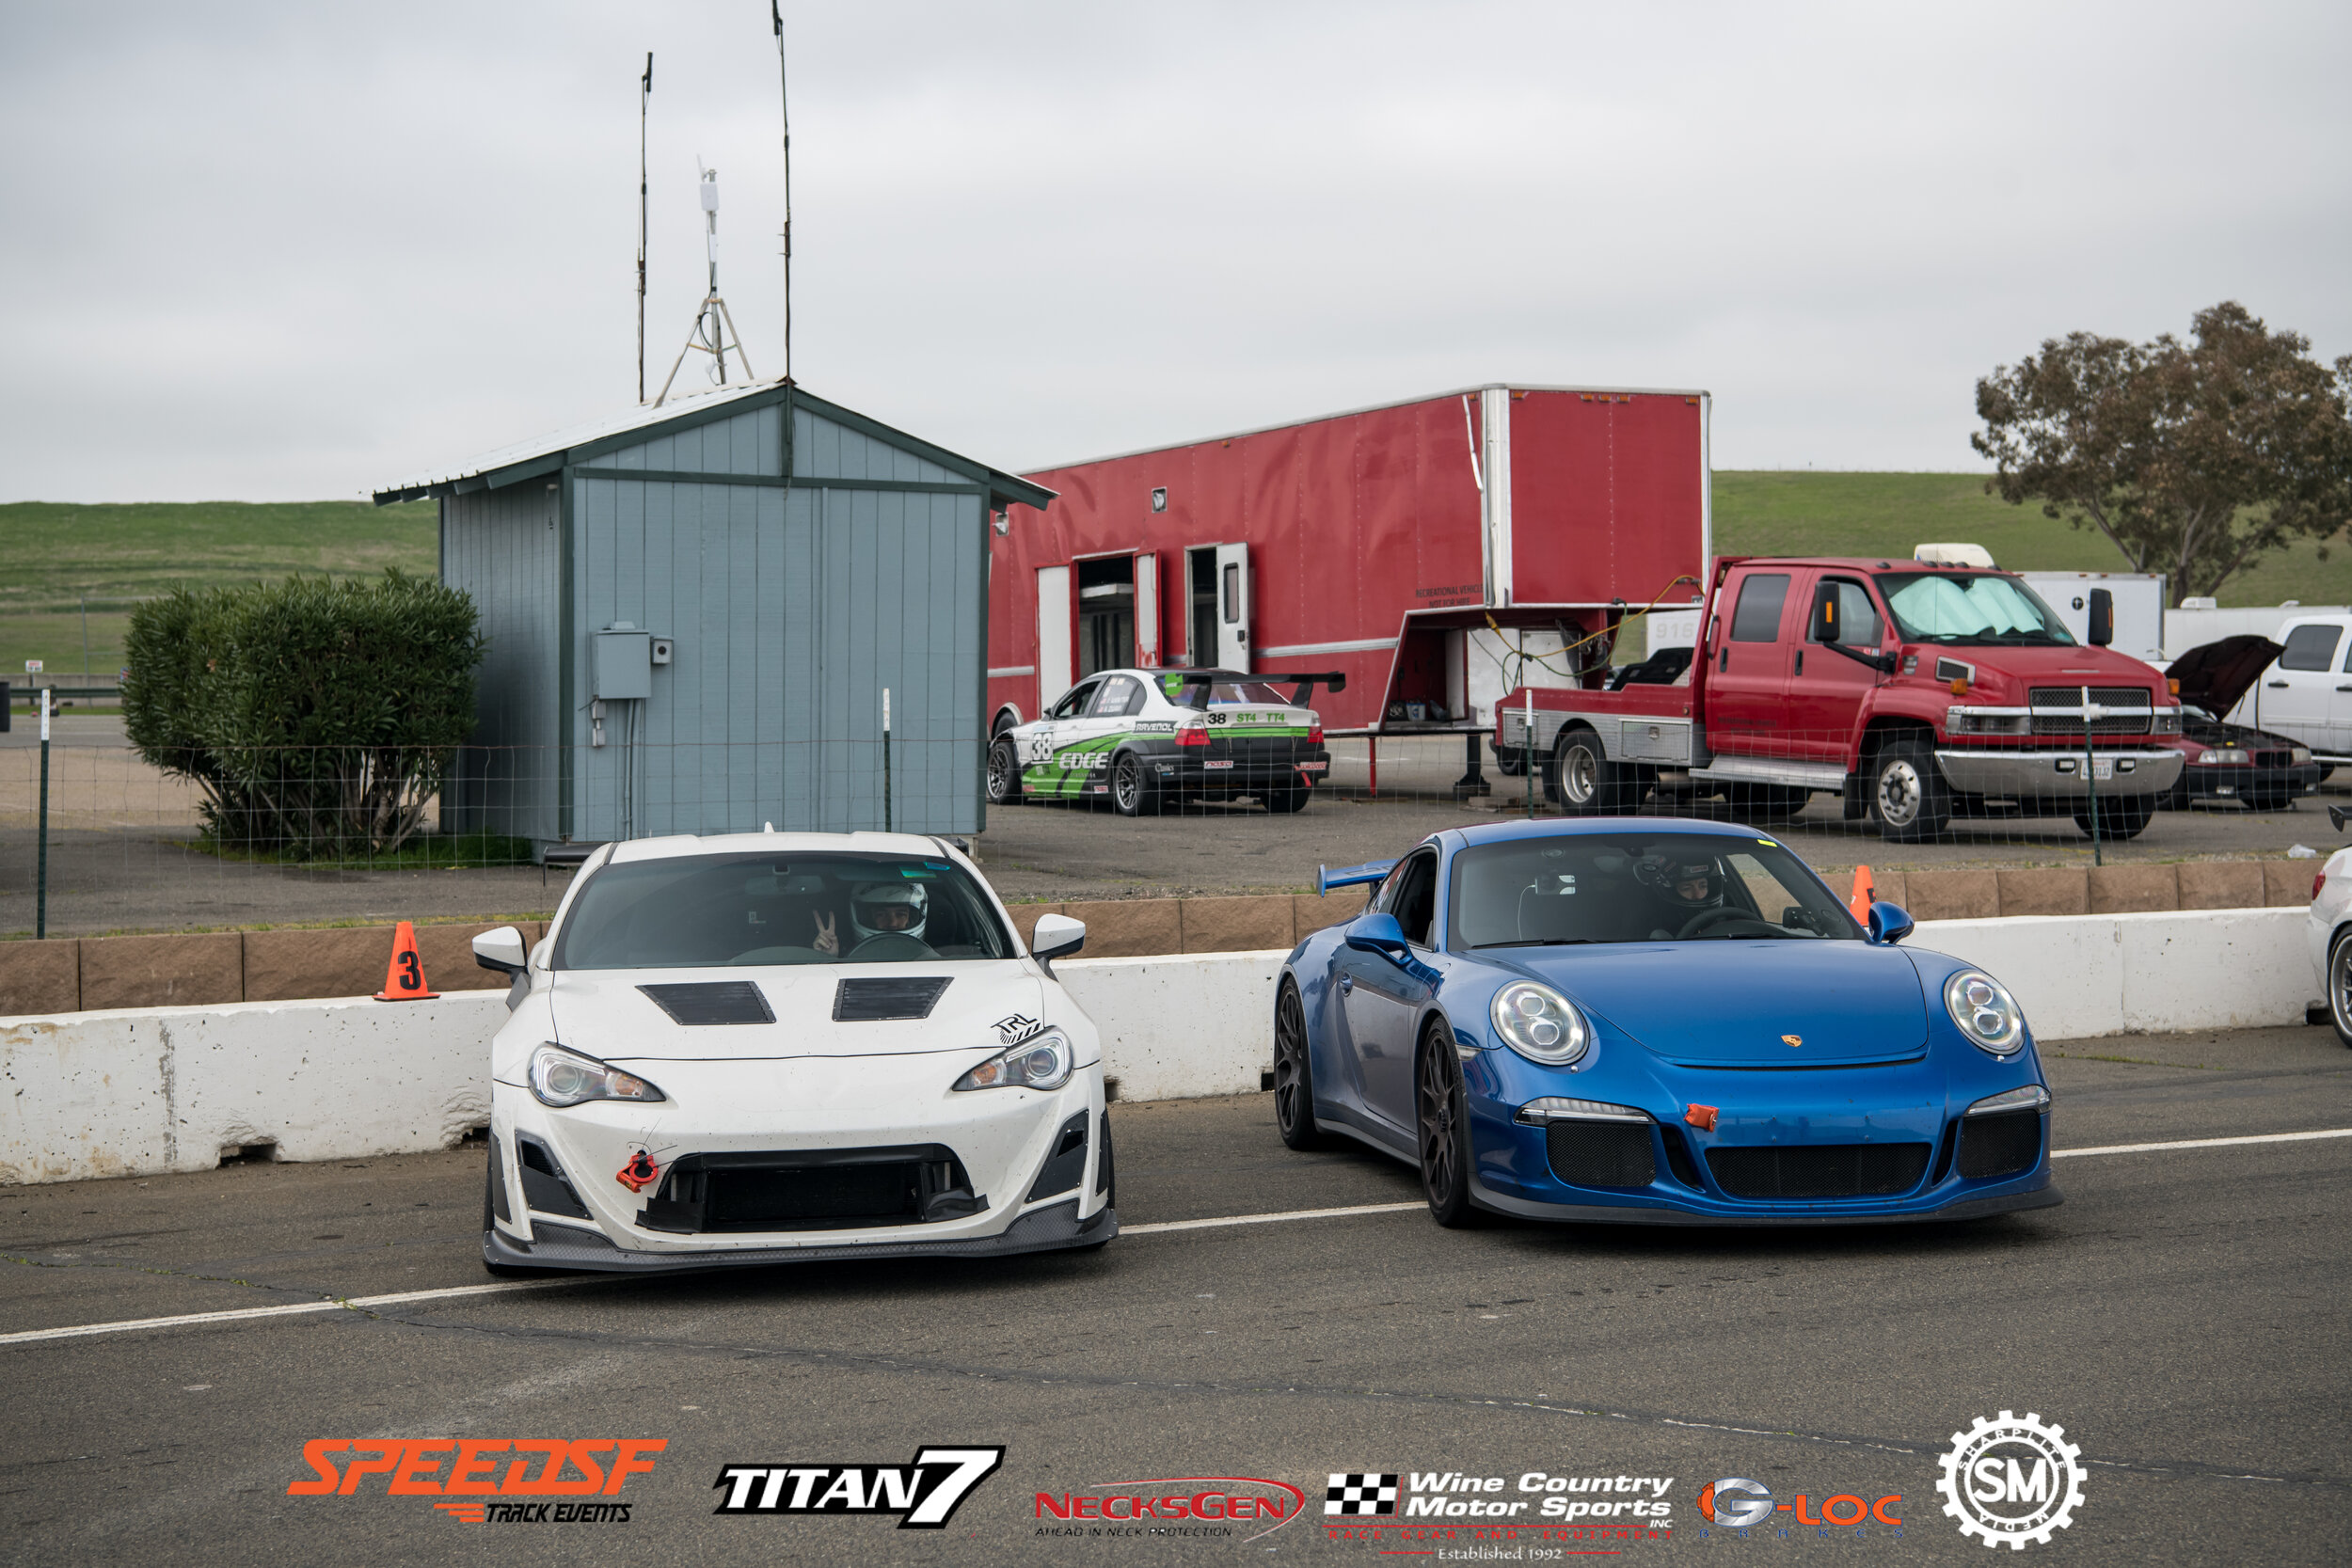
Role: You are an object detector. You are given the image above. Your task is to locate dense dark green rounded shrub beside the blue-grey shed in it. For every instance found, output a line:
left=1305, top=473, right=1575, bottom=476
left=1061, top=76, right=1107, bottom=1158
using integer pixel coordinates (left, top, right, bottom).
left=122, top=571, right=485, bottom=856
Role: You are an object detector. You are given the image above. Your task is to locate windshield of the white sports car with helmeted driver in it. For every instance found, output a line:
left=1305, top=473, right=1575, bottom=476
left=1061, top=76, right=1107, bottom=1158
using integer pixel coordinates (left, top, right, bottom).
left=553, top=853, right=1014, bottom=969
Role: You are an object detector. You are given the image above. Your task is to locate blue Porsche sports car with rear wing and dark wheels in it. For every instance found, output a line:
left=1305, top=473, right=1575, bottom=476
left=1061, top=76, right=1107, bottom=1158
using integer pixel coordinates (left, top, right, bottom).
left=1275, top=818, right=2060, bottom=1225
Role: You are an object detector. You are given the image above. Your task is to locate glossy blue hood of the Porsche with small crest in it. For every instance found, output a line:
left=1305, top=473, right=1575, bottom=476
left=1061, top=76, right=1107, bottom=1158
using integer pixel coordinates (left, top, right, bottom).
left=1519, top=938, right=1927, bottom=1068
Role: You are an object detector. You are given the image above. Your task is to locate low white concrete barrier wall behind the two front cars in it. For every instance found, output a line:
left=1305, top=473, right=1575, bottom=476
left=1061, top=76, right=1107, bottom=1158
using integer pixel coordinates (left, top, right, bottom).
left=0, top=910, right=2317, bottom=1185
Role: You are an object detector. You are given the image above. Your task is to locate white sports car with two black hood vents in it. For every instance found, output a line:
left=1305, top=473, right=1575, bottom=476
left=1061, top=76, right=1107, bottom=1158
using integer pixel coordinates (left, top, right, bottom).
left=473, top=832, right=1120, bottom=1275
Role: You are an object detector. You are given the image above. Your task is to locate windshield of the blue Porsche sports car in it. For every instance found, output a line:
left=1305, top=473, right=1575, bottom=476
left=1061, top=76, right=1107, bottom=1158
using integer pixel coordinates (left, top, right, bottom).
left=1449, top=832, right=1863, bottom=952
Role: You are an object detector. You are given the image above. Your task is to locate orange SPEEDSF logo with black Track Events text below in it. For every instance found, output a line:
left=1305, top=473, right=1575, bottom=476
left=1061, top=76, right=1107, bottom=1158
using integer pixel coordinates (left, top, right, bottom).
left=287, top=1436, right=668, bottom=1524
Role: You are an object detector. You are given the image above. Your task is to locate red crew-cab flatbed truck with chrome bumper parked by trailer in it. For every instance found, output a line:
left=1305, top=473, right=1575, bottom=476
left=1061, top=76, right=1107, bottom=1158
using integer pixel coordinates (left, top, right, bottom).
left=1494, top=550, right=2183, bottom=844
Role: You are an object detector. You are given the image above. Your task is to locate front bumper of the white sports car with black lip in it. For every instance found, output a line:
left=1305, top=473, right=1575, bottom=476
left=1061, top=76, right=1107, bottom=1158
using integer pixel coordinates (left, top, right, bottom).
left=483, top=1051, right=1118, bottom=1270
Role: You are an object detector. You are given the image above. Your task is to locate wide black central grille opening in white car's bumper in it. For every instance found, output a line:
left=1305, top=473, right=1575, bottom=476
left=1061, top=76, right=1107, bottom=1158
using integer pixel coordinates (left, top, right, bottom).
left=638, top=1145, right=988, bottom=1234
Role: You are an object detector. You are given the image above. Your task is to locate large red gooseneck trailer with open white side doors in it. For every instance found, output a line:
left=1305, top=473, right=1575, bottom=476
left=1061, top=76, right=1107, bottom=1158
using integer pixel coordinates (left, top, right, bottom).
left=988, top=386, right=1712, bottom=770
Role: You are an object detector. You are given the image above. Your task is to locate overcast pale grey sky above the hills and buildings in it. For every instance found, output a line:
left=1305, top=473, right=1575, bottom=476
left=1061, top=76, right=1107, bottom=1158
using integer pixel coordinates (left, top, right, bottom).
left=0, top=0, right=2352, bottom=500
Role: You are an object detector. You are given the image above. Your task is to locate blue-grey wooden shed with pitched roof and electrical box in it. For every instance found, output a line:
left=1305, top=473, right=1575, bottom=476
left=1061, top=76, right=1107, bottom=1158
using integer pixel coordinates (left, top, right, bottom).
left=376, top=381, right=1054, bottom=847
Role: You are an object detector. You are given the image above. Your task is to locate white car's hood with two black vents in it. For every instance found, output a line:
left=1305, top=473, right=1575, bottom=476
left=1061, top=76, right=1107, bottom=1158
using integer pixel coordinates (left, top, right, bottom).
left=548, top=959, right=1044, bottom=1063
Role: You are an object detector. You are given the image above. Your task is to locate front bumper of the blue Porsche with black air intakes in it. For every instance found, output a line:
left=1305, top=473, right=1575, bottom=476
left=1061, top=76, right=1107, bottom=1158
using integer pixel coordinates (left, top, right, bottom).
left=1463, top=1051, right=2063, bottom=1225
